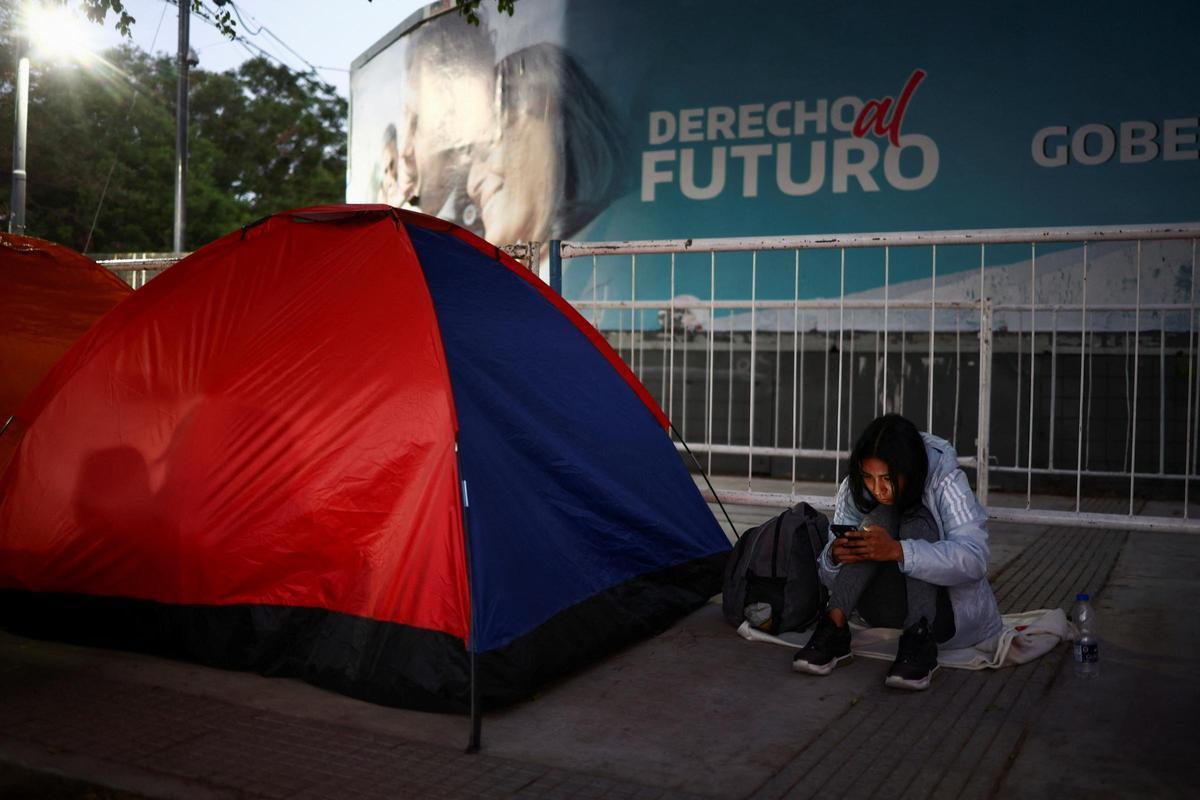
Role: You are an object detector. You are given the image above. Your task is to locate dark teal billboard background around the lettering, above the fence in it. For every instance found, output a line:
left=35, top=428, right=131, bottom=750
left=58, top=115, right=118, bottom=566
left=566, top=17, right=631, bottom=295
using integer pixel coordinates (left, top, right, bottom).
left=561, top=1, right=1200, bottom=237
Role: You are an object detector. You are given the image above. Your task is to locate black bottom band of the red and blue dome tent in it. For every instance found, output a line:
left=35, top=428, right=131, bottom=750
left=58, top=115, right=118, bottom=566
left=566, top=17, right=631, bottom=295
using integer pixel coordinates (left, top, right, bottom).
left=0, top=552, right=727, bottom=714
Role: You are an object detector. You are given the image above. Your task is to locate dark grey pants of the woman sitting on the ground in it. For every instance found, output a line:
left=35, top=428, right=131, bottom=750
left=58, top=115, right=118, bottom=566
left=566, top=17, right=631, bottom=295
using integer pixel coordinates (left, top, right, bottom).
left=829, top=505, right=953, bottom=628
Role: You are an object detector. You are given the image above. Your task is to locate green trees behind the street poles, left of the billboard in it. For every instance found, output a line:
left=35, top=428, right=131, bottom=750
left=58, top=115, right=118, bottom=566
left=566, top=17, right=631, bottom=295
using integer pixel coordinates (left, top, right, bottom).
left=0, top=0, right=347, bottom=252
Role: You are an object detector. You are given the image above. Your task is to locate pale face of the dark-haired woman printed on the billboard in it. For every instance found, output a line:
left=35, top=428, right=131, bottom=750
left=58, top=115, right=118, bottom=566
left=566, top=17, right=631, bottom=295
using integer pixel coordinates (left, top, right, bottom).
left=467, top=113, right=560, bottom=245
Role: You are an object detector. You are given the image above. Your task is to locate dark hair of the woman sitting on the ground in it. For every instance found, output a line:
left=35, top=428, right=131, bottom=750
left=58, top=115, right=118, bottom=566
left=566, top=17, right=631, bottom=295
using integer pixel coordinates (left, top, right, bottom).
left=848, top=414, right=929, bottom=513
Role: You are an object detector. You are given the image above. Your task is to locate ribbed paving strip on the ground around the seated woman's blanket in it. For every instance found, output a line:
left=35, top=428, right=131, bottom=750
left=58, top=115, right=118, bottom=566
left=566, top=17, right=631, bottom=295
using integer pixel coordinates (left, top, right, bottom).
left=754, top=529, right=1128, bottom=798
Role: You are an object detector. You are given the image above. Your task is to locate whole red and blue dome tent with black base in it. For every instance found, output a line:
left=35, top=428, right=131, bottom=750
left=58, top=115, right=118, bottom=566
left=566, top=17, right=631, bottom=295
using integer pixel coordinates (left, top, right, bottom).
left=0, top=206, right=728, bottom=738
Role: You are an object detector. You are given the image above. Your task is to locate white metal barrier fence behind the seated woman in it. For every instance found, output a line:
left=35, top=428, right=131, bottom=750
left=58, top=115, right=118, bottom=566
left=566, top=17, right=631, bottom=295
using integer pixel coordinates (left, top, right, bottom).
left=560, top=223, right=1200, bottom=533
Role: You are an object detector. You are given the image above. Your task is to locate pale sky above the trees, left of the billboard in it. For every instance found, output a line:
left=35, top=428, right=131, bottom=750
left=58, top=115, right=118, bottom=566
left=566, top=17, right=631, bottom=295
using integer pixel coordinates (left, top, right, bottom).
left=89, top=0, right=432, bottom=98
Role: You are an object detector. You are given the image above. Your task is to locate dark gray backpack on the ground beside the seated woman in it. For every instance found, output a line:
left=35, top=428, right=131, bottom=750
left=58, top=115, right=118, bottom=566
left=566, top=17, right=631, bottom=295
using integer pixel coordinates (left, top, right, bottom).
left=721, top=503, right=829, bottom=634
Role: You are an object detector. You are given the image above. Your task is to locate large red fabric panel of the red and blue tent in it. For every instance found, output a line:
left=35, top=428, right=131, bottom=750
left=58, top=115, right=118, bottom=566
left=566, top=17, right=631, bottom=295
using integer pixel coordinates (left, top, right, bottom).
left=0, top=218, right=469, bottom=638
